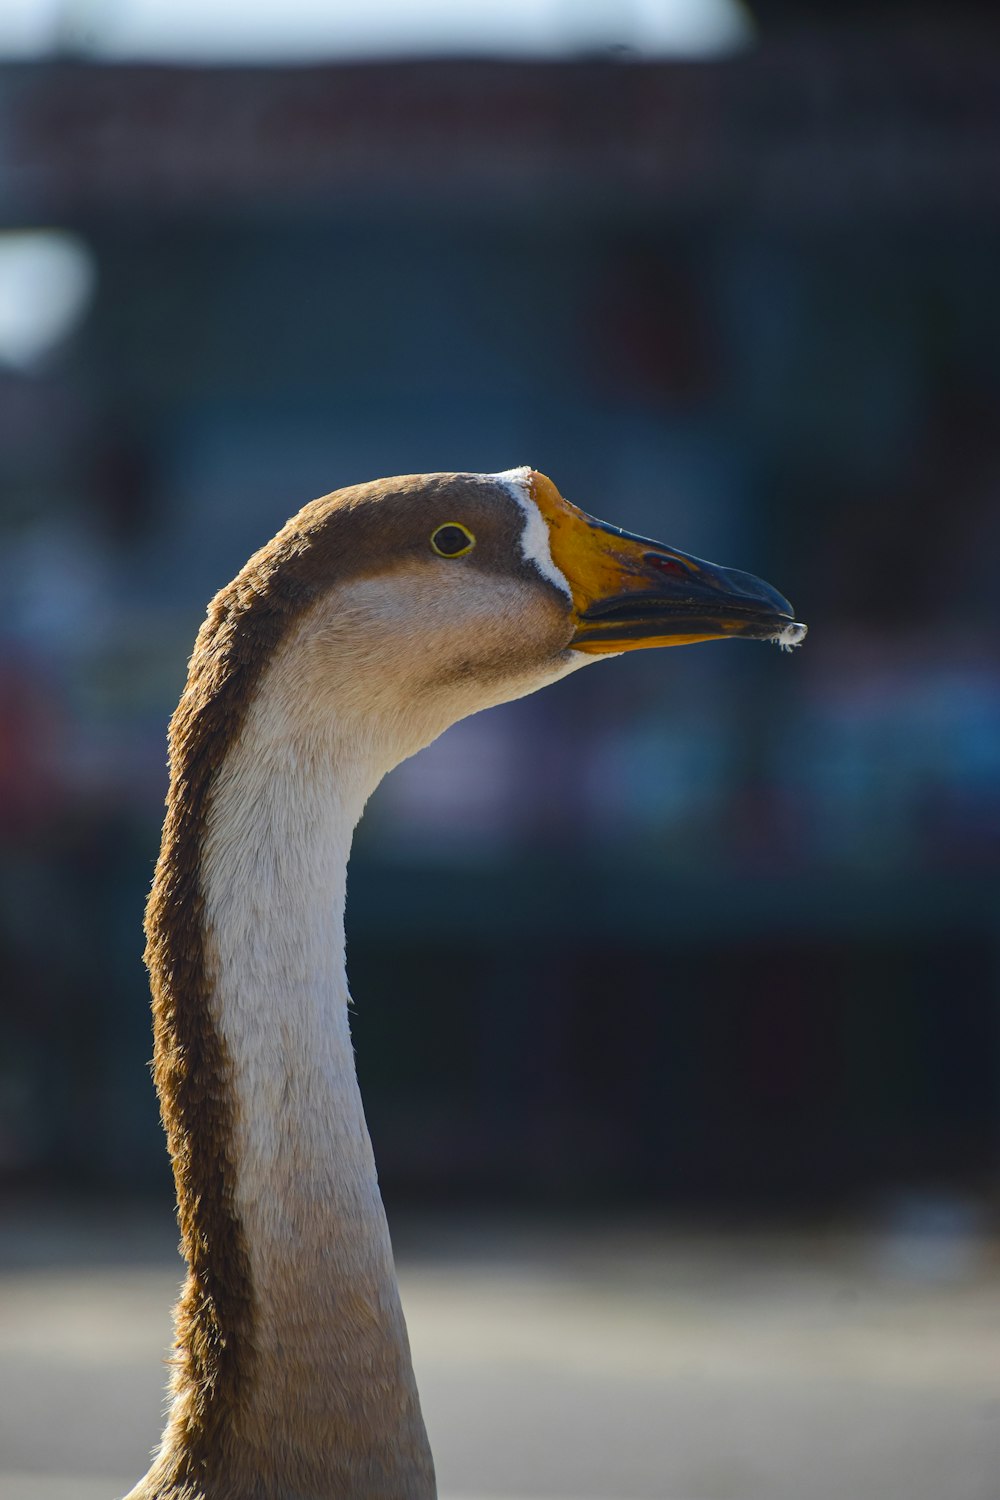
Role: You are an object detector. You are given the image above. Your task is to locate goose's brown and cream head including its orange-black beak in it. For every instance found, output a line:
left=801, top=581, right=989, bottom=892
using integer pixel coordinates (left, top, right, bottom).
left=239, top=468, right=805, bottom=765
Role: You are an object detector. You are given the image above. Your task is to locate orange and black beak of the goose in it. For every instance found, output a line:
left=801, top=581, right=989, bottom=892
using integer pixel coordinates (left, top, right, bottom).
left=531, top=471, right=807, bottom=653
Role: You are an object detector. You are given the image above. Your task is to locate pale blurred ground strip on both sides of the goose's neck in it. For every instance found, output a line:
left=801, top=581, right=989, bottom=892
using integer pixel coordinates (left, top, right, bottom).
left=0, top=1211, right=1000, bottom=1500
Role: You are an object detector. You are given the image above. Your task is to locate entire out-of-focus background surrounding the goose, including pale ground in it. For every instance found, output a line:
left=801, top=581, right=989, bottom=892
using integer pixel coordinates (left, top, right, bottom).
left=0, top=0, right=1000, bottom=1500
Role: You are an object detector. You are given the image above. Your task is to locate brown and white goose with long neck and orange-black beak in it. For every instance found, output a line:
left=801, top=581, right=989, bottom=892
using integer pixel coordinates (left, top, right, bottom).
left=127, top=468, right=805, bottom=1500
